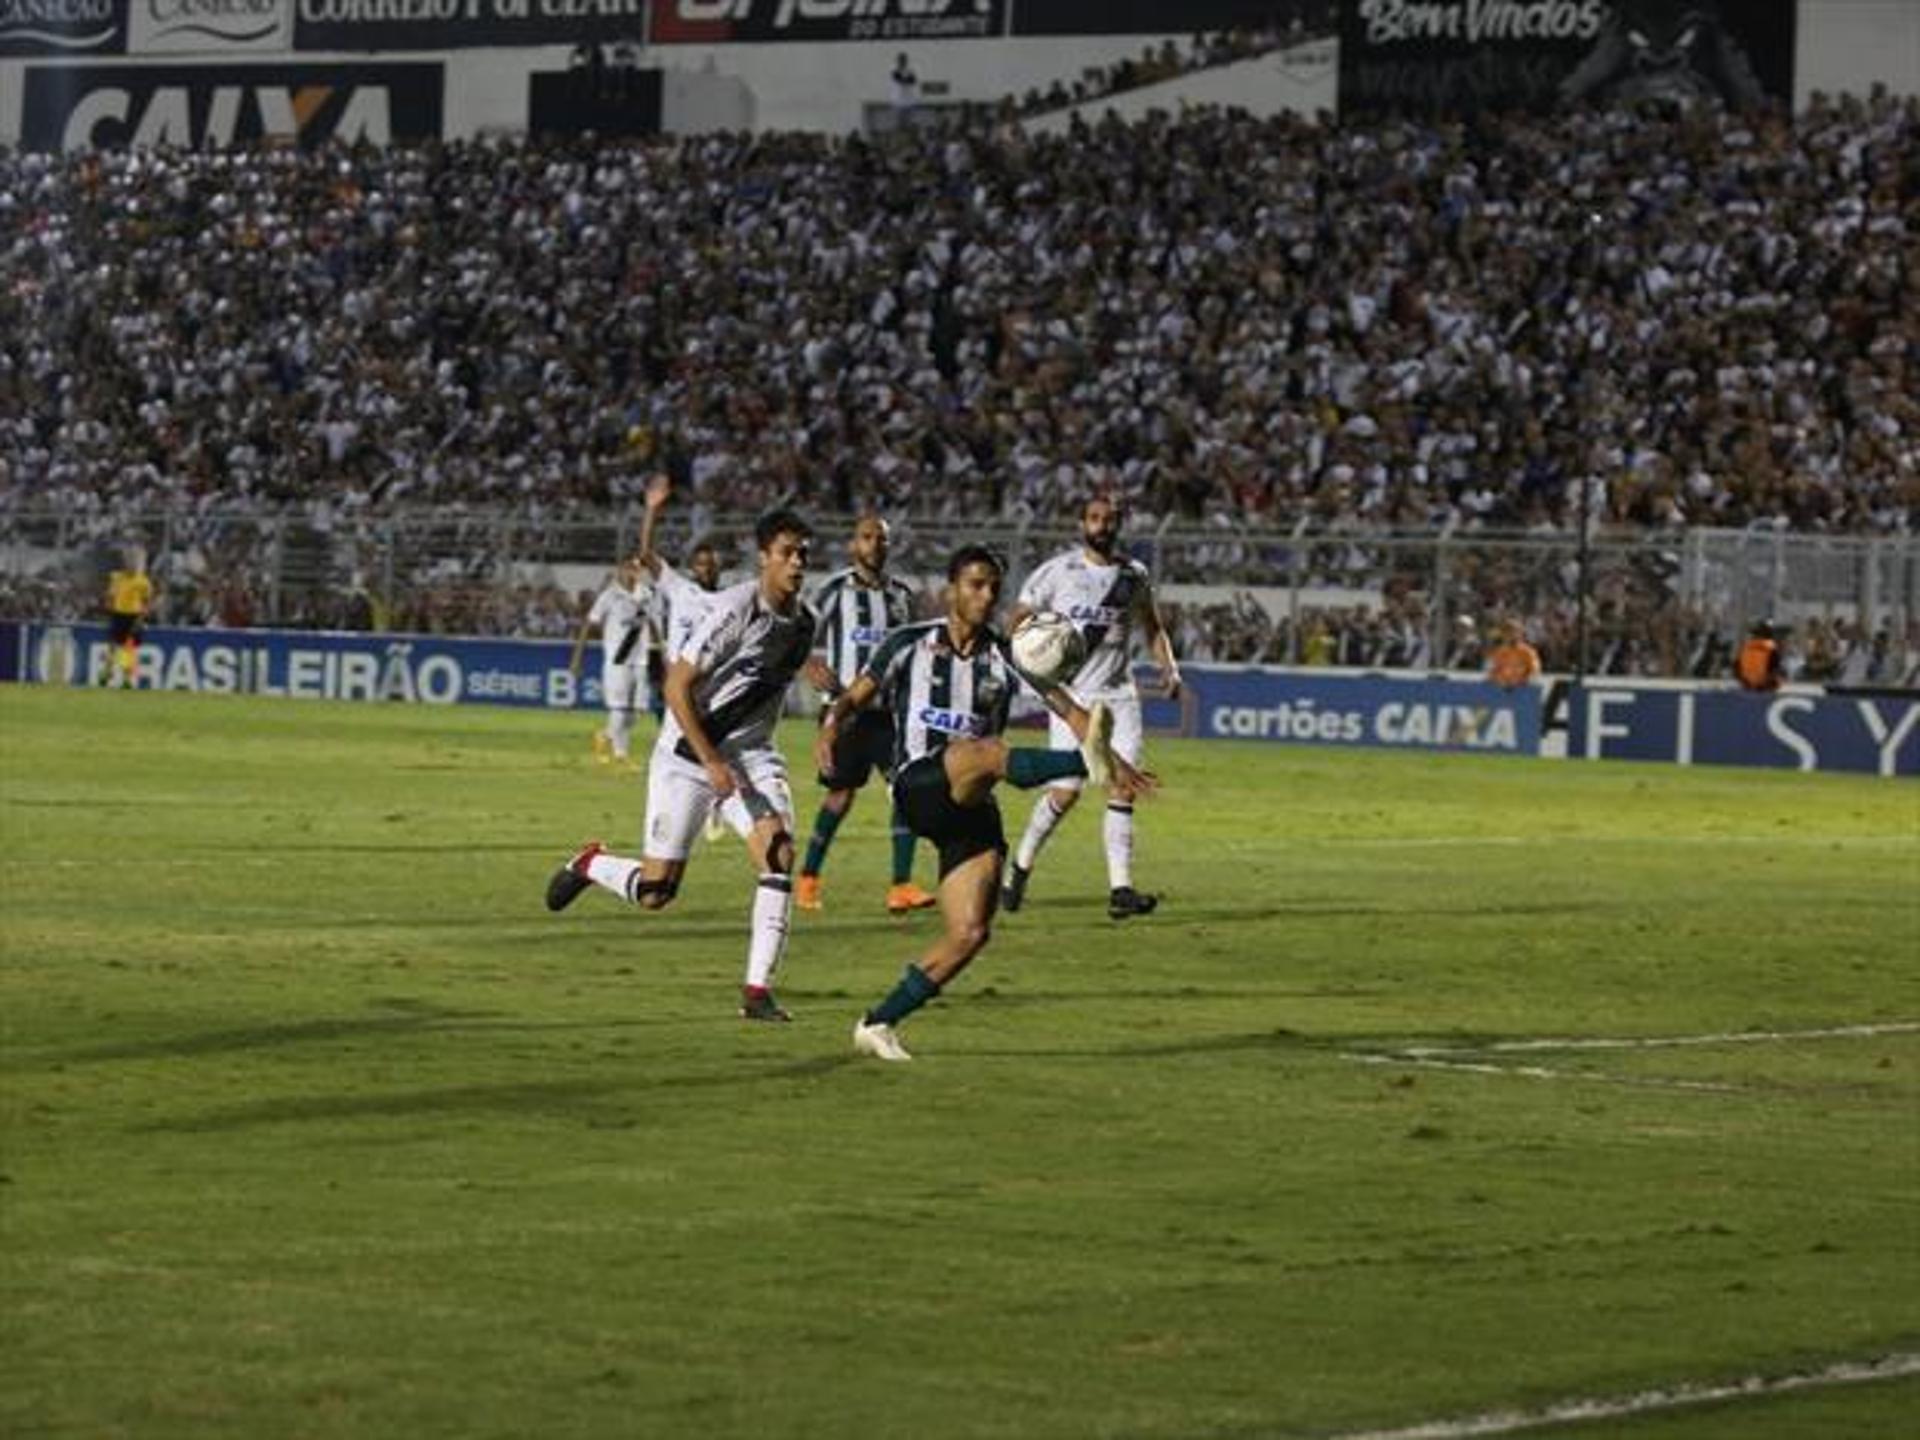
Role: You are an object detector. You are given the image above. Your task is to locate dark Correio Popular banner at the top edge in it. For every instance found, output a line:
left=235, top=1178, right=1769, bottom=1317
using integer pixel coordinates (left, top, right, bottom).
left=293, top=0, right=647, bottom=52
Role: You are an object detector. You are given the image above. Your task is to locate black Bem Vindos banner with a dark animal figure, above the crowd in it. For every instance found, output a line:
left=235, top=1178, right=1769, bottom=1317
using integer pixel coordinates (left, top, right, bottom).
left=1340, top=0, right=1797, bottom=115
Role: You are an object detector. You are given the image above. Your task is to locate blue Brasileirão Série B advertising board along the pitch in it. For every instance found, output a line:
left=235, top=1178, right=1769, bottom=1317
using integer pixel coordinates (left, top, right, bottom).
left=10, top=622, right=601, bottom=710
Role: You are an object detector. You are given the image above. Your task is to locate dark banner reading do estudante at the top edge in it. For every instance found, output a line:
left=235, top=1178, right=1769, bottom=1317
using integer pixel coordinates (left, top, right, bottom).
left=647, top=0, right=1010, bottom=44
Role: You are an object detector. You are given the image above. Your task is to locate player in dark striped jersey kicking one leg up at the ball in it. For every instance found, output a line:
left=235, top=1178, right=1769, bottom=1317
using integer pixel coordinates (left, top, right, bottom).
left=814, top=545, right=1158, bottom=1060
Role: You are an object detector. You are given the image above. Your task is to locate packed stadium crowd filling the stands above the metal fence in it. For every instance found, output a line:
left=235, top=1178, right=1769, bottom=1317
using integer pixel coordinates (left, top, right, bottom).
left=0, top=85, right=1920, bottom=662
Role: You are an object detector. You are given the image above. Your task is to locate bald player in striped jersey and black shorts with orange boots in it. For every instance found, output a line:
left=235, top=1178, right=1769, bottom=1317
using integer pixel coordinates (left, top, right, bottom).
left=793, top=515, right=935, bottom=916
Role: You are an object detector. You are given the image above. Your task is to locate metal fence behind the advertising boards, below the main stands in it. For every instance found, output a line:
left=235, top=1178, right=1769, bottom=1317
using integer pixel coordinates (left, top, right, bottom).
left=0, top=507, right=1920, bottom=684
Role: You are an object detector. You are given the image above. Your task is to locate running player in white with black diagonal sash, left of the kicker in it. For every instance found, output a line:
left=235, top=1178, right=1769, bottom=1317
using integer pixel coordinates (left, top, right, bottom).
left=547, top=511, right=816, bottom=1020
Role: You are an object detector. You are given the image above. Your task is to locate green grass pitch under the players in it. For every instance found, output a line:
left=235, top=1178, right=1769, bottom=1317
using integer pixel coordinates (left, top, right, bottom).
left=0, top=687, right=1920, bottom=1440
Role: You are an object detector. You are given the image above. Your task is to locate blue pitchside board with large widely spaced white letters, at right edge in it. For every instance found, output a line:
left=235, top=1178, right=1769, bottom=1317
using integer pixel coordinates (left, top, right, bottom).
left=1567, top=684, right=1920, bottom=776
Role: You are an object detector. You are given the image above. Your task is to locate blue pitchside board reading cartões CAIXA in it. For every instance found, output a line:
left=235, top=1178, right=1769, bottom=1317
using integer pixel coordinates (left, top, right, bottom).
left=1142, top=664, right=1540, bottom=755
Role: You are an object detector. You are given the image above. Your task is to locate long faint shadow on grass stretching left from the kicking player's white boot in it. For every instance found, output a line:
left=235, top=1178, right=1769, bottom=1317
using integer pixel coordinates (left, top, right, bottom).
left=144, top=1054, right=860, bottom=1135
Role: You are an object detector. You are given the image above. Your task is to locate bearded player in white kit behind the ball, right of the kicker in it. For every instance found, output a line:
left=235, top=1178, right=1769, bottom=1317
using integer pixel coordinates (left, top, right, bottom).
left=1000, top=495, right=1181, bottom=920
